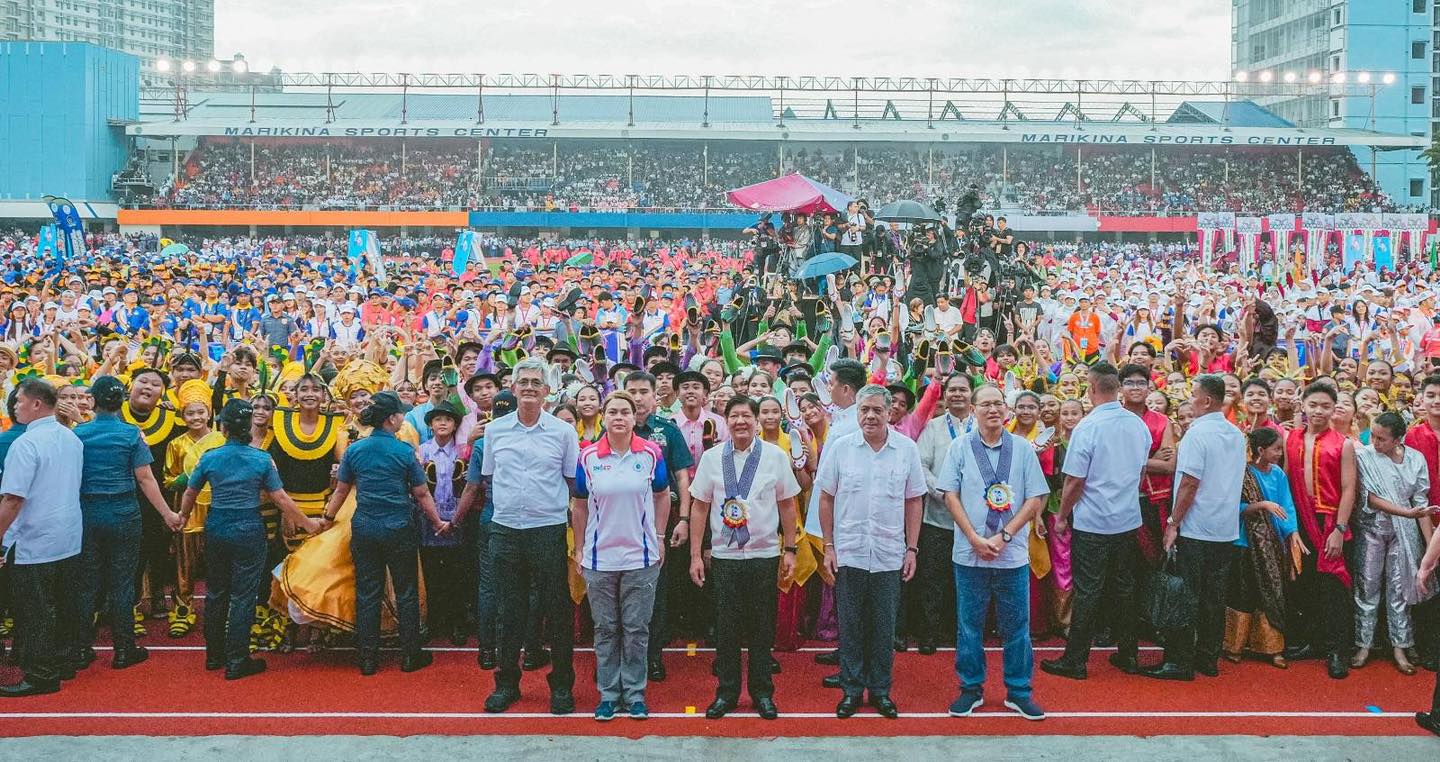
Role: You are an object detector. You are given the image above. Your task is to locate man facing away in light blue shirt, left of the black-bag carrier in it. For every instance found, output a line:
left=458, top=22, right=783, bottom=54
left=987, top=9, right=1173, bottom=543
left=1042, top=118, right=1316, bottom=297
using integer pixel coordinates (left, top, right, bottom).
left=1040, top=363, right=1151, bottom=680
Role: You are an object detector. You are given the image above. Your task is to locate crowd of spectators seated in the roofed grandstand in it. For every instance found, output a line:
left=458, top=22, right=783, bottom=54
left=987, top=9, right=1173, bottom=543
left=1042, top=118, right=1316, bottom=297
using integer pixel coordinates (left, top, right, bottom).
left=148, top=138, right=1397, bottom=215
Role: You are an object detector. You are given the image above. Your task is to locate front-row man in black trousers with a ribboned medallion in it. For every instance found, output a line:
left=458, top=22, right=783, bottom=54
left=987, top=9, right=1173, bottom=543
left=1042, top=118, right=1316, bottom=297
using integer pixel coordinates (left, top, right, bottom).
left=690, top=396, right=801, bottom=720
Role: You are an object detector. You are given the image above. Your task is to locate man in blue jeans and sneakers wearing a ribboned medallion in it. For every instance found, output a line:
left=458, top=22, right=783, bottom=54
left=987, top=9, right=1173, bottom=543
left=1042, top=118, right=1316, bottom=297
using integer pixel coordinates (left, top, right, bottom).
left=937, top=385, right=1050, bottom=720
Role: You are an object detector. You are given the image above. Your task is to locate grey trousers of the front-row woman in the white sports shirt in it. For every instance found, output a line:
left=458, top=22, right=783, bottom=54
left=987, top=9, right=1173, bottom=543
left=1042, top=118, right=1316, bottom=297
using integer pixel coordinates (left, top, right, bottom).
left=580, top=563, right=660, bottom=706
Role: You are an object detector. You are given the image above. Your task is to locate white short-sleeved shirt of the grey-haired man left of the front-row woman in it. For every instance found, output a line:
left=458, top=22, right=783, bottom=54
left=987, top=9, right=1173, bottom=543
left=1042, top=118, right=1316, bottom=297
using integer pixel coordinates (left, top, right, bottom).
left=480, top=411, right=580, bottom=529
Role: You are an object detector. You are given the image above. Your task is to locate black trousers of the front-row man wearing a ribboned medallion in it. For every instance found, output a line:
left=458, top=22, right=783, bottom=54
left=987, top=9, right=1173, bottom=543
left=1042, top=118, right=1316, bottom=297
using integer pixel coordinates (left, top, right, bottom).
left=708, top=556, right=780, bottom=702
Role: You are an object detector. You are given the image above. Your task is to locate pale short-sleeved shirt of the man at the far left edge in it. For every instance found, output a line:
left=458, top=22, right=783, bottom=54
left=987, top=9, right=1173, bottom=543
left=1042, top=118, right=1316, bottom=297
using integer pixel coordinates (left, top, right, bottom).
left=0, top=415, right=85, bottom=563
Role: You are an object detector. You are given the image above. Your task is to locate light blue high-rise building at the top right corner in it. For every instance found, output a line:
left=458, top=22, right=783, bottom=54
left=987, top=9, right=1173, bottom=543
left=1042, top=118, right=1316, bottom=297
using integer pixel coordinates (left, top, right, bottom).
left=1230, top=0, right=1440, bottom=206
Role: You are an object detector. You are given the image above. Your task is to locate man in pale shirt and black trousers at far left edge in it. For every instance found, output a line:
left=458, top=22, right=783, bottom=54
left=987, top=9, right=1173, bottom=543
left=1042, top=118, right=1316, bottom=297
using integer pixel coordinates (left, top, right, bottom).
left=0, top=379, right=85, bottom=697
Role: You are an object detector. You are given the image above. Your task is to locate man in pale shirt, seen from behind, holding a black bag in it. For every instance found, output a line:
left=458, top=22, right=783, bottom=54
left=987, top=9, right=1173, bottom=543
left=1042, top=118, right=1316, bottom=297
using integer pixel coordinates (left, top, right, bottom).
left=1140, top=375, right=1246, bottom=680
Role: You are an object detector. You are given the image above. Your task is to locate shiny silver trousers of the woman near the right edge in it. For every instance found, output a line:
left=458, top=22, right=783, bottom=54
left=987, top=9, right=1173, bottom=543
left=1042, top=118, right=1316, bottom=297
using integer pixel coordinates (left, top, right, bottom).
left=1355, top=513, right=1416, bottom=648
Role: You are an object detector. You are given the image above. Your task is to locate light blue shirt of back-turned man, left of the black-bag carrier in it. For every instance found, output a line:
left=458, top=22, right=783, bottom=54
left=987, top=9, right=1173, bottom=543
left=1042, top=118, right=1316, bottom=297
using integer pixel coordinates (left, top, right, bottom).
left=1061, top=402, right=1152, bottom=534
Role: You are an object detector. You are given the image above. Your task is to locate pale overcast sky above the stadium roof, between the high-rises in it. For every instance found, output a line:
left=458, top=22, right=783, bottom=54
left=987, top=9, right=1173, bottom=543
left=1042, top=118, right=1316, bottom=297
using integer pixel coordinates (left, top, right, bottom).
left=215, top=0, right=1230, bottom=79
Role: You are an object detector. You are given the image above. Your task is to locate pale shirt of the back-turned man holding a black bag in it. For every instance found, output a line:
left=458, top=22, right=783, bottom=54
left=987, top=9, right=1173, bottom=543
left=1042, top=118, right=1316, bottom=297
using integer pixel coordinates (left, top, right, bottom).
left=1175, top=412, right=1246, bottom=543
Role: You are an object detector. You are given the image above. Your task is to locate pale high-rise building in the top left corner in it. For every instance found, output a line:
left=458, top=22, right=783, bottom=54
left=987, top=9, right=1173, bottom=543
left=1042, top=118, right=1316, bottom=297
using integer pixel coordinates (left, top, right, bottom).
left=0, top=0, right=215, bottom=79
